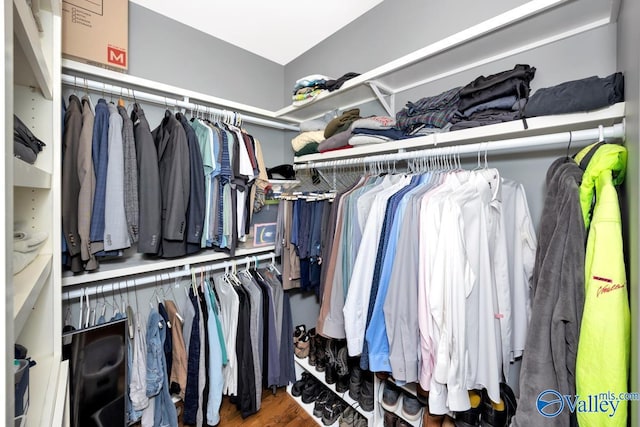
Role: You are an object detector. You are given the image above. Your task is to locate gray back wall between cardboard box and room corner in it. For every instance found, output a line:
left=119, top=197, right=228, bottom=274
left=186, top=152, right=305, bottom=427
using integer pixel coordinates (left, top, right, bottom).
left=129, top=2, right=284, bottom=110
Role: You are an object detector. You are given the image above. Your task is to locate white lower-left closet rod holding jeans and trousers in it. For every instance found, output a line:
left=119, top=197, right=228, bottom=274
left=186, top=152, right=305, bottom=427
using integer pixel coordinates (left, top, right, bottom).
left=62, top=252, right=276, bottom=301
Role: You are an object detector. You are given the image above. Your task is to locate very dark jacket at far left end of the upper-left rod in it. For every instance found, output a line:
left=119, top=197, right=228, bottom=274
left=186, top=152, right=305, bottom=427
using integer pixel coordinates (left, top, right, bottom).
left=62, top=95, right=82, bottom=271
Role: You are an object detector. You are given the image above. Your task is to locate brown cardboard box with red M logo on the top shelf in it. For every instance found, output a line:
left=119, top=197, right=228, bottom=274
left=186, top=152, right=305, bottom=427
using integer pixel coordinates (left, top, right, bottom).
left=62, top=0, right=129, bottom=71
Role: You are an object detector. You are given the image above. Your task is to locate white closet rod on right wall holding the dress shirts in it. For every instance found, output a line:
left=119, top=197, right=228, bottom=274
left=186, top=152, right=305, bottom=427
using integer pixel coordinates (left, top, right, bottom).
left=293, top=123, right=624, bottom=170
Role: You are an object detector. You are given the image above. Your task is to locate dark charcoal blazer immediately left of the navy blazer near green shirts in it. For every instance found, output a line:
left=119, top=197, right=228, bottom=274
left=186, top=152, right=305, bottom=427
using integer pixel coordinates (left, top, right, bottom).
left=152, top=111, right=190, bottom=258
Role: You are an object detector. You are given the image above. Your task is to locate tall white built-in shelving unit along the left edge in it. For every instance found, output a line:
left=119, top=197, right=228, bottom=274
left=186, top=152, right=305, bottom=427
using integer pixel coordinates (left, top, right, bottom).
left=1, top=0, right=68, bottom=426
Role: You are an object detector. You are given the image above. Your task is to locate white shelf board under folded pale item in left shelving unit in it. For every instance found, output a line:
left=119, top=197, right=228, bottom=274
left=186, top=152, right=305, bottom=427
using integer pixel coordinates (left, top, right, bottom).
left=13, top=254, right=53, bottom=336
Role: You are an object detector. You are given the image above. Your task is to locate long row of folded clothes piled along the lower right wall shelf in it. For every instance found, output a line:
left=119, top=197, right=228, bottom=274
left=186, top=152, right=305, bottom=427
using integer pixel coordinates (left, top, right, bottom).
left=292, top=64, right=624, bottom=156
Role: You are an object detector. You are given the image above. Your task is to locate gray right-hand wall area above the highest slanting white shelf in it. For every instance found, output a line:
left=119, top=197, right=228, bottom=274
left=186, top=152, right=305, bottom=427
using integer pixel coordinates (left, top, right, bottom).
left=284, top=0, right=526, bottom=105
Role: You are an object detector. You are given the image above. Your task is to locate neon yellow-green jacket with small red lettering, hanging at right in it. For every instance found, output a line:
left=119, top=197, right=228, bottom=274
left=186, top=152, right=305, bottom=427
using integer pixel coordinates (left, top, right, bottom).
left=576, top=144, right=631, bottom=427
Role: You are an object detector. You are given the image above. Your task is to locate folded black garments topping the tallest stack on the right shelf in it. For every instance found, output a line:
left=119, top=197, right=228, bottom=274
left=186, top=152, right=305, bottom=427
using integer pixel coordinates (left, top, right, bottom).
left=458, top=64, right=536, bottom=111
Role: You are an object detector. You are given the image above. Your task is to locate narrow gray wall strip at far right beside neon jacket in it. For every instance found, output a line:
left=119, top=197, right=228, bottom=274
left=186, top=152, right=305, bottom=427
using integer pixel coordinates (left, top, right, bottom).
left=617, top=0, right=640, bottom=426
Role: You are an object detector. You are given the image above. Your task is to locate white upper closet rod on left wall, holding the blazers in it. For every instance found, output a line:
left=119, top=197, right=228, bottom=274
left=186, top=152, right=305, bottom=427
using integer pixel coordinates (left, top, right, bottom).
left=61, top=74, right=300, bottom=132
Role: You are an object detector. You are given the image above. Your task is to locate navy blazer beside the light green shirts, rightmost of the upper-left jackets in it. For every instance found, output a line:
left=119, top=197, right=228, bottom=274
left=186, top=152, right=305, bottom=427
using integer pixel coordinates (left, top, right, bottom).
left=176, top=113, right=206, bottom=254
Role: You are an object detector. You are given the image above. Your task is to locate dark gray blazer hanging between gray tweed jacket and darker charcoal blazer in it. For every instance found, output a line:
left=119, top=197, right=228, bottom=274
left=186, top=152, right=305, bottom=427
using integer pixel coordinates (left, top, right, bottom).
left=131, top=104, right=162, bottom=254
